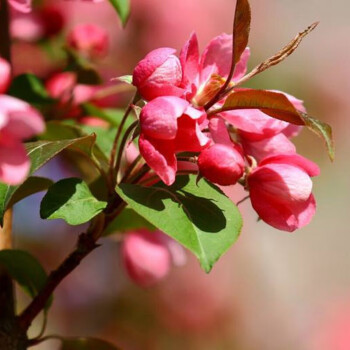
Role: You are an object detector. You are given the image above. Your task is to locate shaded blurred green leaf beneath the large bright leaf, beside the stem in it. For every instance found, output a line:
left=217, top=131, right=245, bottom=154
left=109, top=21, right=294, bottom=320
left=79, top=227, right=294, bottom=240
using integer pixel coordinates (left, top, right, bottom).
left=103, top=208, right=156, bottom=236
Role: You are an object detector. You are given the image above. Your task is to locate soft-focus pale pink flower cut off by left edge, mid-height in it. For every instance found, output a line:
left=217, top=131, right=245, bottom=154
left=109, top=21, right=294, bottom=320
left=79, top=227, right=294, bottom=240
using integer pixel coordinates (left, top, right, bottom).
left=0, top=95, right=45, bottom=185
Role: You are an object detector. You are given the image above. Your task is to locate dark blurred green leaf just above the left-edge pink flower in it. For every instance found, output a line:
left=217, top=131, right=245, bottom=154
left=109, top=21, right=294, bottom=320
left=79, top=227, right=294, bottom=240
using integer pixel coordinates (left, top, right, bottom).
left=8, top=74, right=54, bottom=104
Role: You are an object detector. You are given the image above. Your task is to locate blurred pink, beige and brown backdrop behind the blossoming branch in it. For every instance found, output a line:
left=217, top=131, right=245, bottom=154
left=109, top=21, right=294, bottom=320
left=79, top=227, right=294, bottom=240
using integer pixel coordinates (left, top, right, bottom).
left=8, top=0, right=350, bottom=350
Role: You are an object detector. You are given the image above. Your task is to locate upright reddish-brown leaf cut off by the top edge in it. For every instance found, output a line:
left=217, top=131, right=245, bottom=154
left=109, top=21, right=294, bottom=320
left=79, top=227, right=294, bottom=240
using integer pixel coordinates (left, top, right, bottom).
left=233, top=0, right=251, bottom=63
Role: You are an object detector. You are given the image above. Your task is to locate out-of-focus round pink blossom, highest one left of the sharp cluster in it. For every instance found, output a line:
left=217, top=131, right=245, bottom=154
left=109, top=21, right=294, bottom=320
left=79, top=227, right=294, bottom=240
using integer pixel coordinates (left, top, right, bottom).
left=67, top=24, right=109, bottom=58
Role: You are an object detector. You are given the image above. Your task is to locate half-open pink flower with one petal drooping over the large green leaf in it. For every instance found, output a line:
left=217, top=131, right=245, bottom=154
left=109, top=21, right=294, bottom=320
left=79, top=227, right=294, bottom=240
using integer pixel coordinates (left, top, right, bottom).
left=139, top=96, right=210, bottom=185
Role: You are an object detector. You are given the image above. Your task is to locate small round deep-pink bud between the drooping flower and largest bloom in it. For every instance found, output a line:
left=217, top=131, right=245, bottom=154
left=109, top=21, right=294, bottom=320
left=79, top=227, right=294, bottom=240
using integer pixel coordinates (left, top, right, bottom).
left=198, top=143, right=244, bottom=186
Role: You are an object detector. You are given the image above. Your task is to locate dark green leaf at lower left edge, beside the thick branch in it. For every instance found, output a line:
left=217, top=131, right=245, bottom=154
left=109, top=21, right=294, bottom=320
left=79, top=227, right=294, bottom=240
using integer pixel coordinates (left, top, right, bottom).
left=0, top=249, right=52, bottom=308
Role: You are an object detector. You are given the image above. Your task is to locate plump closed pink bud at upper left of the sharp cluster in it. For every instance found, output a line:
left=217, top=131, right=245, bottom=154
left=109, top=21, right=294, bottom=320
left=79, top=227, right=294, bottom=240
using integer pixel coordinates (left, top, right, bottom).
left=133, top=48, right=184, bottom=100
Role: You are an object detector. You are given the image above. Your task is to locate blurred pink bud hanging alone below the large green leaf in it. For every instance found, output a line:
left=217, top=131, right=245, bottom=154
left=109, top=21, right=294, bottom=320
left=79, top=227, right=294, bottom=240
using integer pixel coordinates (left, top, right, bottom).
left=122, top=230, right=171, bottom=287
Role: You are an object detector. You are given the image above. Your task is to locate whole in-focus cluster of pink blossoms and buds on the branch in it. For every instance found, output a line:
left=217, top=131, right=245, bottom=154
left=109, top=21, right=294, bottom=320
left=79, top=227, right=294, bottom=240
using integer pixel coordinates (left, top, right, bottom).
left=133, top=34, right=319, bottom=231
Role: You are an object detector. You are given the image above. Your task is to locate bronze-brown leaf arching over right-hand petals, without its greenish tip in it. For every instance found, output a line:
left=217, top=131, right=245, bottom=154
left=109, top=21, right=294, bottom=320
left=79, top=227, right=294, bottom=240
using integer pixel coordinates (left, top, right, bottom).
left=220, top=89, right=304, bottom=125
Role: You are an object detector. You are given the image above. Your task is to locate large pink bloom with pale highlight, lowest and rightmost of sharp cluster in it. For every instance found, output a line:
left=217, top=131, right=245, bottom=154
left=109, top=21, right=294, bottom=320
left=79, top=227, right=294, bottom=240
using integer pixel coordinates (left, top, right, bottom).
left=248, top=154, right=319, bottom=232
